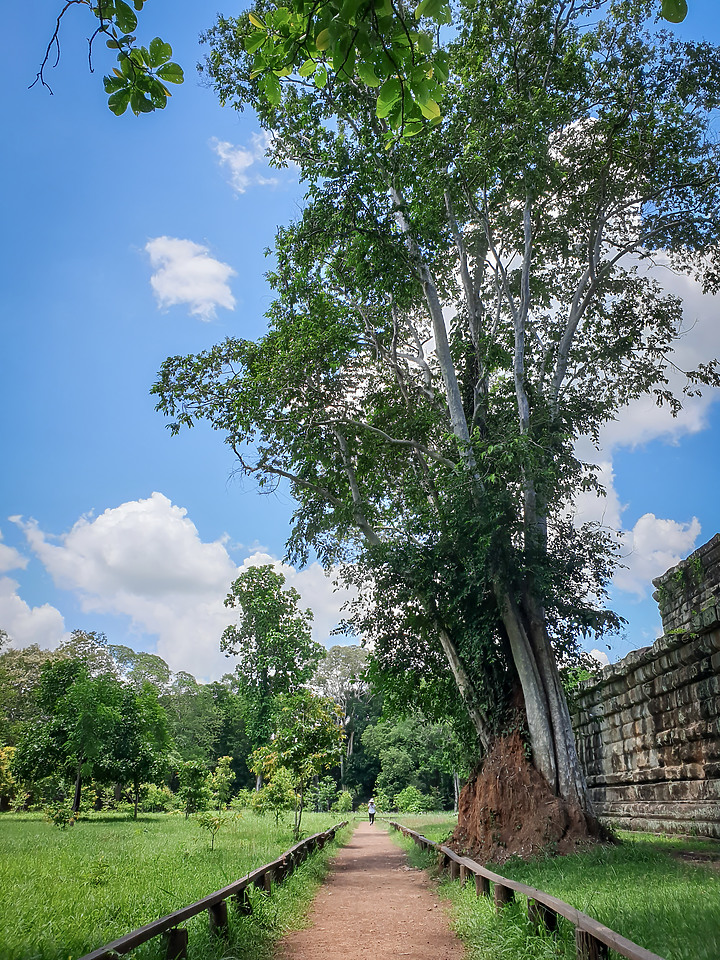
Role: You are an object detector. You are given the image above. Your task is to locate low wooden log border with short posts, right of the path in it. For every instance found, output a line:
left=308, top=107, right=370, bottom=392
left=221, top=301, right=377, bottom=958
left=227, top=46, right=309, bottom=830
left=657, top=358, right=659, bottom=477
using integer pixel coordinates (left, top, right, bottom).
left=388, top=820, right=663, bottom=960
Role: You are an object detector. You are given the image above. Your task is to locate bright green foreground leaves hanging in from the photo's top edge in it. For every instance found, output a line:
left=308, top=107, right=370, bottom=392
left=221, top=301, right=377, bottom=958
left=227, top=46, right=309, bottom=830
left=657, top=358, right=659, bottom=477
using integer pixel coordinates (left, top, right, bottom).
left=35, top=0, right=688, bottom=123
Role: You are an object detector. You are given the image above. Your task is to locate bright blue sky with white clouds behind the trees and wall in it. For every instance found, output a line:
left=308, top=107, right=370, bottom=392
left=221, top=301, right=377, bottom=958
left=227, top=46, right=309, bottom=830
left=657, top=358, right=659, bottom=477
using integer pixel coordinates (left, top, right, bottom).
left=0, top=0, right=720, bottom=678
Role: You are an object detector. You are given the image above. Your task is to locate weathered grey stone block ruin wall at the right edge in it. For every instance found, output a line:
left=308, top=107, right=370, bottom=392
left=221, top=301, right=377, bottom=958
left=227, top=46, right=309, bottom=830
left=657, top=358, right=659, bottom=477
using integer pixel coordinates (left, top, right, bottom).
left=571, top=534, right=720, bottom=839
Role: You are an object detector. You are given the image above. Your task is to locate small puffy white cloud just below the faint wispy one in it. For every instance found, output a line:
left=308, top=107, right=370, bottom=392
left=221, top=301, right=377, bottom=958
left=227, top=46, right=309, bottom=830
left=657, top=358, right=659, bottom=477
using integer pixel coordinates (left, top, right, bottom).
left=145, top=237, right=236, bottom=321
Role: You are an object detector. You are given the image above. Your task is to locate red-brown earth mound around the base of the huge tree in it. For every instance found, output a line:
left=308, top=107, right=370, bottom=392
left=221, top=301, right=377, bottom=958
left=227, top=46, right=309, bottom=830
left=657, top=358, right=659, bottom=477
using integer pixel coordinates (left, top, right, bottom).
left=449, top=732, right=609, bottom=863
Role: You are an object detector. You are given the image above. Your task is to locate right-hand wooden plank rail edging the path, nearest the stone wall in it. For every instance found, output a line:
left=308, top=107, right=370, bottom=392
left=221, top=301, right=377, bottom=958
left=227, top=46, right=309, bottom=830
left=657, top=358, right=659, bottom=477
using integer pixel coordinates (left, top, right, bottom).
left=387, top=820, right=663, bottom=960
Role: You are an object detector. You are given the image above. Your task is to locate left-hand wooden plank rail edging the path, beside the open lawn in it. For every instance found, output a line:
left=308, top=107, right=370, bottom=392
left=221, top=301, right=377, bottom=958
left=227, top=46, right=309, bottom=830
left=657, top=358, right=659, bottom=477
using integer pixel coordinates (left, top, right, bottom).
left=80, top=820, right=348, bottom=960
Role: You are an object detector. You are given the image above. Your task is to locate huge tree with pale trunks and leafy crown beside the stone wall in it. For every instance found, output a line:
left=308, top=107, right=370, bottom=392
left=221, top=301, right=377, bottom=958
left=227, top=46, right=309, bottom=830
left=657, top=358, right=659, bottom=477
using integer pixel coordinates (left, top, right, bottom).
left=154, top=0, right=720, bottom=852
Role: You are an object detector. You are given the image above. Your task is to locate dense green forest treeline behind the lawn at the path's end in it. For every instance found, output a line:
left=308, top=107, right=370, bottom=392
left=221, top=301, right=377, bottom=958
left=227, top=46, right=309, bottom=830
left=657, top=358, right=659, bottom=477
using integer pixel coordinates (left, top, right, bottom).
left=0, top=630, right=467, bottom=823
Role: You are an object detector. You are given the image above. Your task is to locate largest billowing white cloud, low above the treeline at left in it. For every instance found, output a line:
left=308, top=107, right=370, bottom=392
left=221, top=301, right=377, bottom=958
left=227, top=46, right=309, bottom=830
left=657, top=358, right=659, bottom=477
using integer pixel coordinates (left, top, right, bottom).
left=14, top=493, right=354, bottom=680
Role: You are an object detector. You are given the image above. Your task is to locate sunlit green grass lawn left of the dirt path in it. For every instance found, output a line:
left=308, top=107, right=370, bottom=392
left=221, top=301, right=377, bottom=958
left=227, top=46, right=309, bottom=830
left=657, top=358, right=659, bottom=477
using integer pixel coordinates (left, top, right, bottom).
left=0, top=813, right=348, bottom=960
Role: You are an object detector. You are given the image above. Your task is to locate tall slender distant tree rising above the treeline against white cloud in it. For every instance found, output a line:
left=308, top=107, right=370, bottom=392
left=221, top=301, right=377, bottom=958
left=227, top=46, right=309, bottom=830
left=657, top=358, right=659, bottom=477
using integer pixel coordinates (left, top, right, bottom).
left=220, top=564, right=322, bottom=787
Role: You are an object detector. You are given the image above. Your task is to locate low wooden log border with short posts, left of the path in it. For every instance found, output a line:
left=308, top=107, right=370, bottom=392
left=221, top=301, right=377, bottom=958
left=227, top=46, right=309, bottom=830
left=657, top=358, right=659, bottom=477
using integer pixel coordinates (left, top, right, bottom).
left=80, top=820, right=348, bottom=960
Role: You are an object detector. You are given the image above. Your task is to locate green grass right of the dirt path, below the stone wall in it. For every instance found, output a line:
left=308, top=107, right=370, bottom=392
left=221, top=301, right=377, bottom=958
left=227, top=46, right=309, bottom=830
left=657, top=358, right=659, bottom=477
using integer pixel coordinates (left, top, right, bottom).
left=390, top=828, right=720, bottom=960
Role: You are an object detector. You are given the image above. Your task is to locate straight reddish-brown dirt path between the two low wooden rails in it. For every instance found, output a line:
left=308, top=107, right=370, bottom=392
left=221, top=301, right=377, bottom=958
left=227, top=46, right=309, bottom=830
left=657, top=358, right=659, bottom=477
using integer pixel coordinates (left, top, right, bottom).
left=278, top=823, right=464, bottom=960
